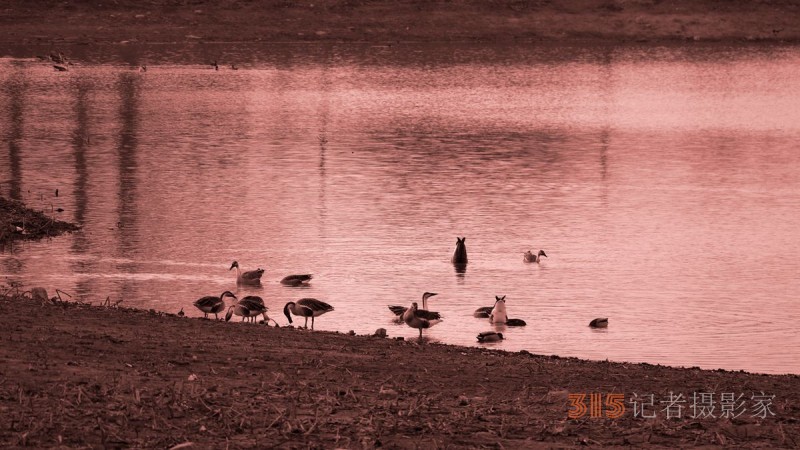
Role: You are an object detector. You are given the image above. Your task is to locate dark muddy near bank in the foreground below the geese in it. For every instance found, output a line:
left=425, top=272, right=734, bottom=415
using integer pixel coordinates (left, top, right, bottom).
left=0, top=289, right=800, bottom=448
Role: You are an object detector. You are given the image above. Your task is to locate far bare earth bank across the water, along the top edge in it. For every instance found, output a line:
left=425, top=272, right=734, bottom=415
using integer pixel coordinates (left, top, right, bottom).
left=0, top=0, right=800, bottom=45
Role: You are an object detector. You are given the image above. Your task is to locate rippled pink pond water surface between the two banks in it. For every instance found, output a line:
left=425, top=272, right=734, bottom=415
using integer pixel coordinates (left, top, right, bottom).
left=0, top=46, right=800, bottom=373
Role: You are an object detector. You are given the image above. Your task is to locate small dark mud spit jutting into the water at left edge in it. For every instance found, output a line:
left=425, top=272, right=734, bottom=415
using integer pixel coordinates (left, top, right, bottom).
left=0, top=196, right=79, bottom=250
